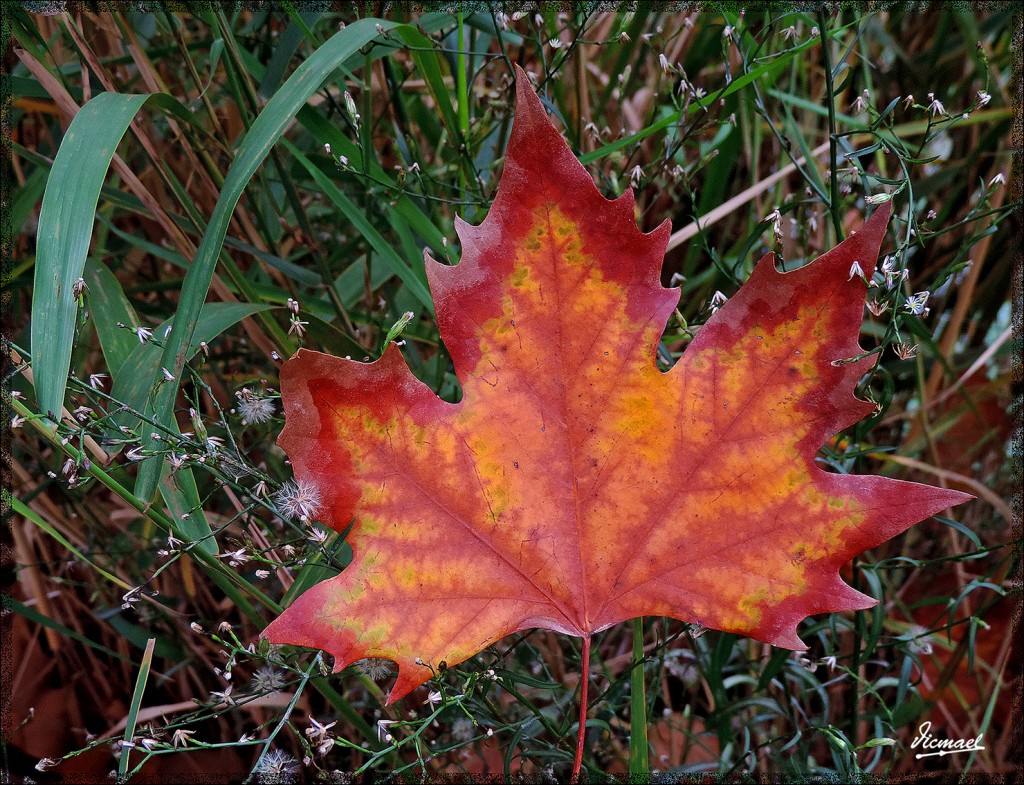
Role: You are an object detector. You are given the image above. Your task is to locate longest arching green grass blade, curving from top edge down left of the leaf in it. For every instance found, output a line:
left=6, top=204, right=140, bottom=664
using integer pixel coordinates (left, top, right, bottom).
left=135, top=18, right=396, bottom=499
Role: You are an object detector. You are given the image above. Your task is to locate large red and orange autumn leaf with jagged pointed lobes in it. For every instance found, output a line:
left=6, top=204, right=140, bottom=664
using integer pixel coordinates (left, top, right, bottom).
left=266, top=72, right=970, bottom=702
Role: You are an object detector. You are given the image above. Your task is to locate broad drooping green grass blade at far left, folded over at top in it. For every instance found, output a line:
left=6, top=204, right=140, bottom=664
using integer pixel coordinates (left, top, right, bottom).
left=32, top=93, right=150, bottom=429
